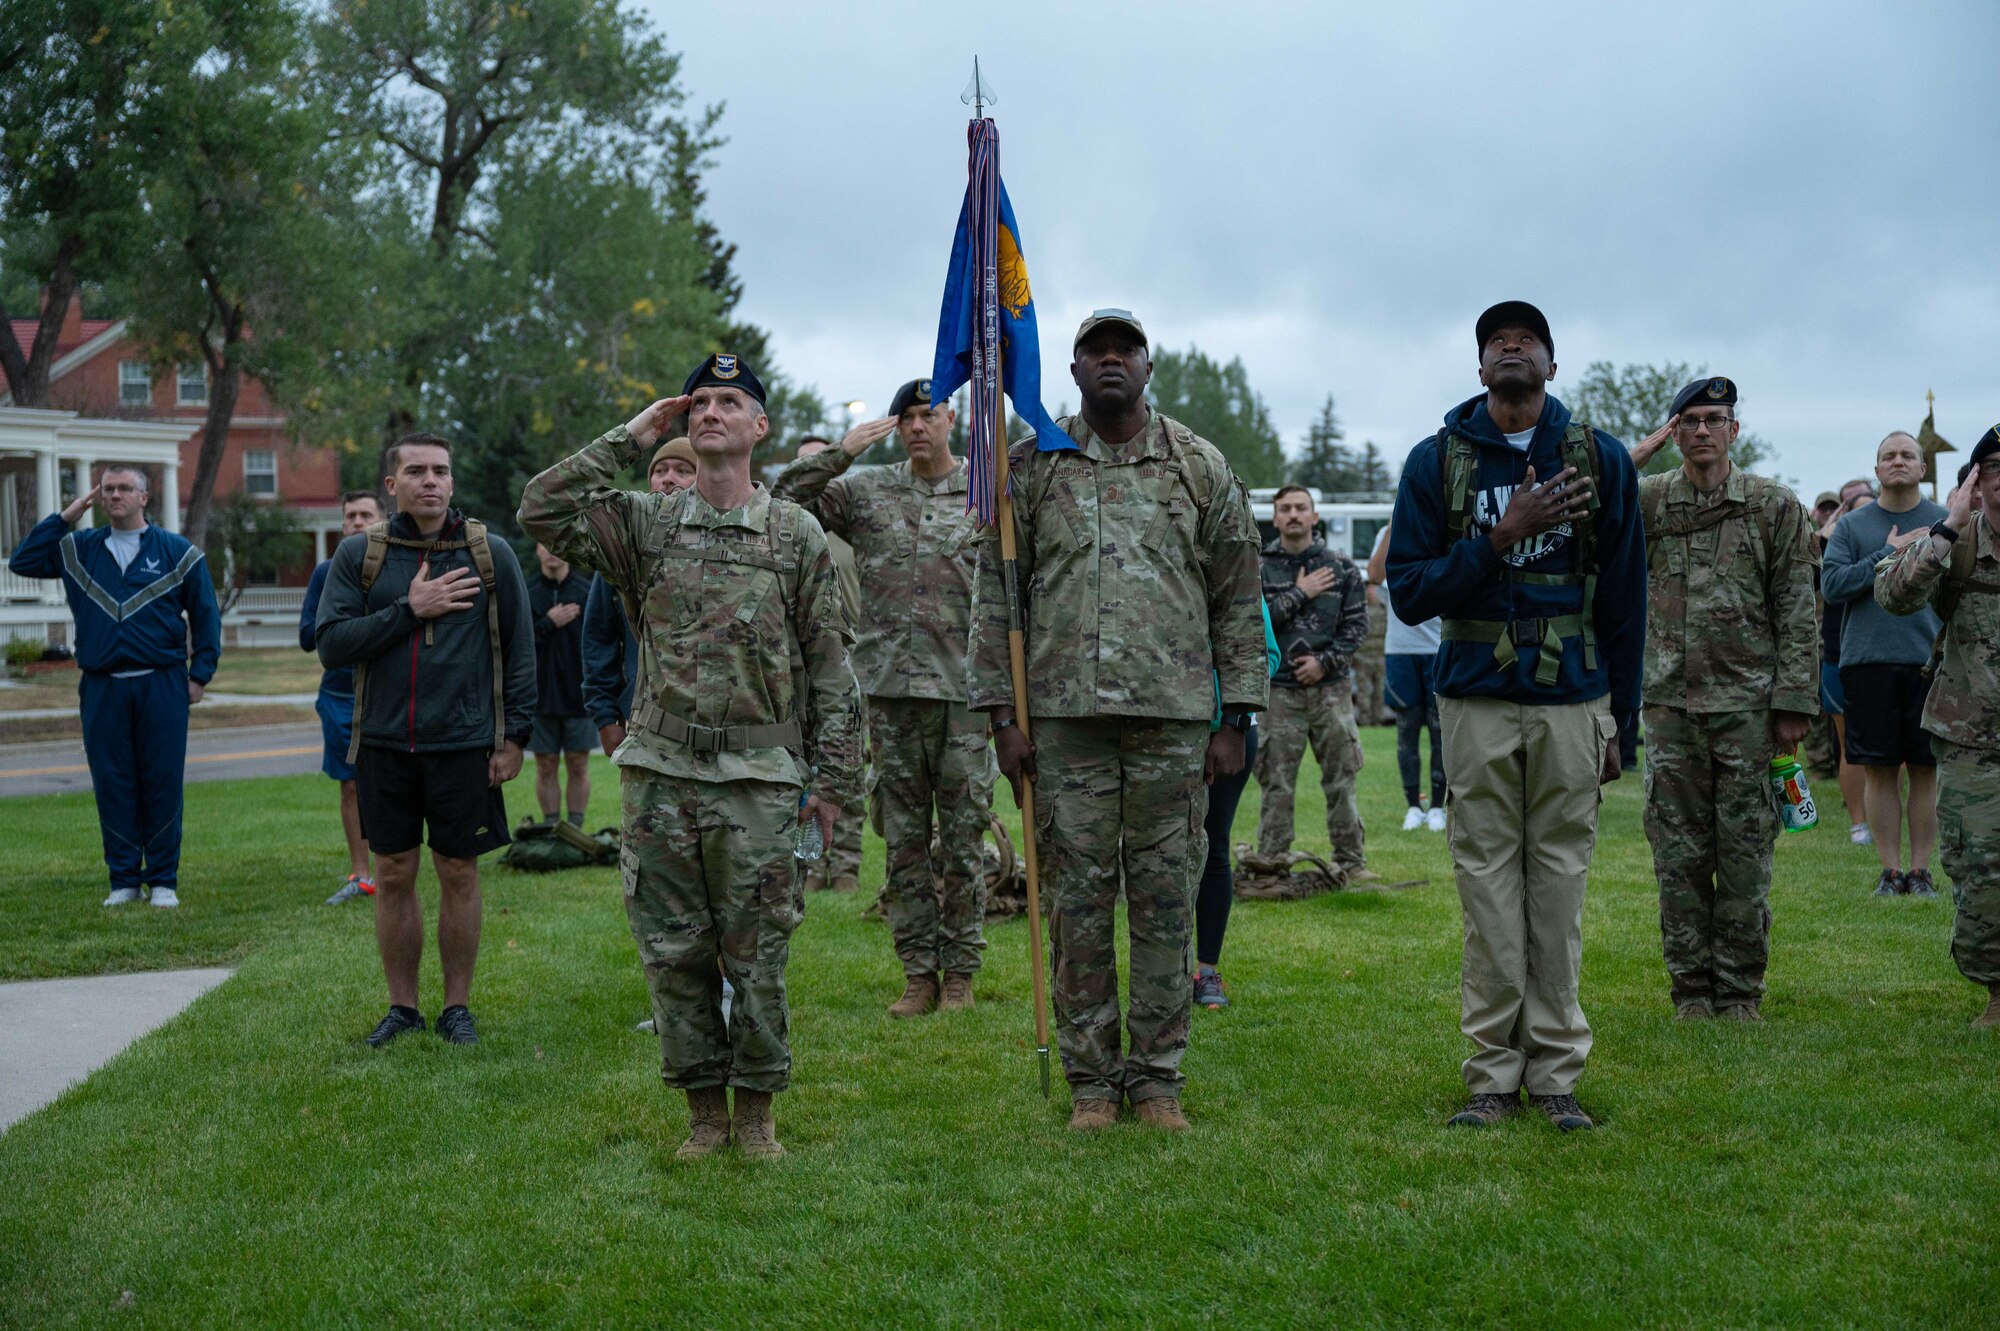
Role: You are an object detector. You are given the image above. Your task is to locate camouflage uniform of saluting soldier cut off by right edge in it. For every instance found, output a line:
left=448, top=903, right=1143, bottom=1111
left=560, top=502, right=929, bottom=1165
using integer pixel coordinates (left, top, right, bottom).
left=1874, top=512, right=2000, bottom=987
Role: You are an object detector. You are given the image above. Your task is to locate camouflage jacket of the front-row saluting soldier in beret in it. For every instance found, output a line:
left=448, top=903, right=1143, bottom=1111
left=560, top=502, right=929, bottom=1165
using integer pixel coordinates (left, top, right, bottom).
left=520, top=426, right=862, bottom=811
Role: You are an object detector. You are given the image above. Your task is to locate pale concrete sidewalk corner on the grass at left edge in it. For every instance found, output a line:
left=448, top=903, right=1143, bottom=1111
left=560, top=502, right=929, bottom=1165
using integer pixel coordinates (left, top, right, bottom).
left=0, top=963, right=232, bottom=1133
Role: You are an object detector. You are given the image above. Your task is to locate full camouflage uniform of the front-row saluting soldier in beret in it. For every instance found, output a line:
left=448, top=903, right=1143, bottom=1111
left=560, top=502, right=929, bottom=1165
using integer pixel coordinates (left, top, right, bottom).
left=520, top=426, right=860, bottom=1091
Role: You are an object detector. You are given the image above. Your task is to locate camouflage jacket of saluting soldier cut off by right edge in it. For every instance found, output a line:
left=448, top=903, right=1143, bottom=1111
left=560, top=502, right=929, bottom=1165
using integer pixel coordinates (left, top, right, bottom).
left=1874, top=514, right=2000, bottom=749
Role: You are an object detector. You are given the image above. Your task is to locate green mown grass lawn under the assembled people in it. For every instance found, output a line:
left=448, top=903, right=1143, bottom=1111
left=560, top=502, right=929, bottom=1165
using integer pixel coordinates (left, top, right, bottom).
left=0, top=729, right=2000, bottom=1327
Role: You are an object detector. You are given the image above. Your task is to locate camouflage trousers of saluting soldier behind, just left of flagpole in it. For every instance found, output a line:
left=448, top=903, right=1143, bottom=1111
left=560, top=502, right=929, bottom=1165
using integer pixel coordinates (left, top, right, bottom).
left=868, top=697, right=994, bottom=975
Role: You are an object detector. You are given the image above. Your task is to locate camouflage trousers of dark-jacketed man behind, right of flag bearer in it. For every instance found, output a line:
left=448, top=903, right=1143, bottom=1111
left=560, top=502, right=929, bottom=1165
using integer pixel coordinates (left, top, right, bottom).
left=1256, top=677, right=1368, bottom=875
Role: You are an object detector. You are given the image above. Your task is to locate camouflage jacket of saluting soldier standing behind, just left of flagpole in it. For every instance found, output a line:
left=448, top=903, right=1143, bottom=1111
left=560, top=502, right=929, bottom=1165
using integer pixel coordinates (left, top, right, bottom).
left=772, top=448, right=978, bottom=703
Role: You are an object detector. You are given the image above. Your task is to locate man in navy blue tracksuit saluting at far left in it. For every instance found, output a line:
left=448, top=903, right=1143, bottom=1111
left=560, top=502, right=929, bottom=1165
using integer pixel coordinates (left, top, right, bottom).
left=8, top=464, right=222, bottom=907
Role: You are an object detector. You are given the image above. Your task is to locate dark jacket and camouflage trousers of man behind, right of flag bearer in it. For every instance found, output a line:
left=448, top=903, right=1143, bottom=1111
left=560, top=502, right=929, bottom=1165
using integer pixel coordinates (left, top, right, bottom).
left=1256, top=540, right=1380, bottom=875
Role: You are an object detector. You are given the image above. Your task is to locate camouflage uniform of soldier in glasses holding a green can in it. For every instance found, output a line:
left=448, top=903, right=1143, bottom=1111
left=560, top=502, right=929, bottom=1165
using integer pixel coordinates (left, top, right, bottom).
left=1640, top=468, right=1820, bottom=1005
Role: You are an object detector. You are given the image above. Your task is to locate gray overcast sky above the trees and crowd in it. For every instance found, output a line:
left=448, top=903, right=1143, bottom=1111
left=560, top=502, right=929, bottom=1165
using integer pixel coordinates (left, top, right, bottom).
left=650, top=0, right=2000, bottom=492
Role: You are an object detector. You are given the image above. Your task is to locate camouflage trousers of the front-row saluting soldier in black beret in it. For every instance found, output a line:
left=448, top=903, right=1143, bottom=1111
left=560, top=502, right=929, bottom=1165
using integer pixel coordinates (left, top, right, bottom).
left=618, top=767, right=806, bottom=1091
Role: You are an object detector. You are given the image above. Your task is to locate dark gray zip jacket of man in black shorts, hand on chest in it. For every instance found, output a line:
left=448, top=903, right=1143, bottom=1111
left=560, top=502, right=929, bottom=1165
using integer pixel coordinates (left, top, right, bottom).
left=316, top=510, right=534, bottom=753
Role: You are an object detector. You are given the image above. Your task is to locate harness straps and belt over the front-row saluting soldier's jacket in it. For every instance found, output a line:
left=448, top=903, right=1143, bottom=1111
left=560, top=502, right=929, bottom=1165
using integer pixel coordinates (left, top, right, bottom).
left=626, top=490, right=804, bottom=753
